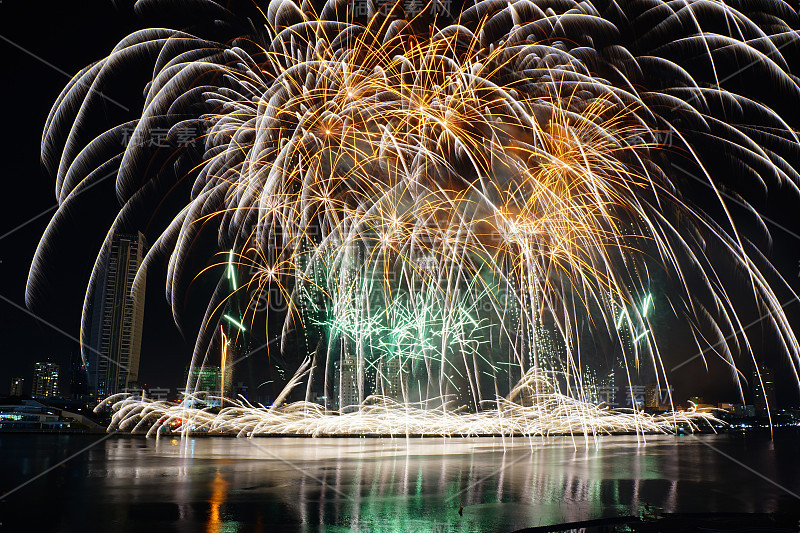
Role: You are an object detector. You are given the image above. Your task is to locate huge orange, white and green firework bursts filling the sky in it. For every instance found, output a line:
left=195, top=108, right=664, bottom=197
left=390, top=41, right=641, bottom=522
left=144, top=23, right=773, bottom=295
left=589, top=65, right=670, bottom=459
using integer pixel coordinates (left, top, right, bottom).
left=27, top=0, right=800, bottom=434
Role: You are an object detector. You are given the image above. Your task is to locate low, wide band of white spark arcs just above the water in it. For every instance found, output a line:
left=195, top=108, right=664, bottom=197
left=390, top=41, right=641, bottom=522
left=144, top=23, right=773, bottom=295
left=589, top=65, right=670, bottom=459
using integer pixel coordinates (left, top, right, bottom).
left=98, top=373, right=718, bottom=437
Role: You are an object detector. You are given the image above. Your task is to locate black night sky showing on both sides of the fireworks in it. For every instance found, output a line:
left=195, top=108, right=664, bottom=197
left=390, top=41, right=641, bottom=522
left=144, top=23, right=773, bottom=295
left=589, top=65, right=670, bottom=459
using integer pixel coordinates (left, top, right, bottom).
left=0, top=0, right=800, bottom=404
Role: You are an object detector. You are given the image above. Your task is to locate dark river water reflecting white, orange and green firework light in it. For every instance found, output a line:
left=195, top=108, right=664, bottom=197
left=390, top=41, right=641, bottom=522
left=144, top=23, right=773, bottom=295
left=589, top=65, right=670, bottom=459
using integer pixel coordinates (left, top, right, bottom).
left=0, top=436, right=800, bottom=533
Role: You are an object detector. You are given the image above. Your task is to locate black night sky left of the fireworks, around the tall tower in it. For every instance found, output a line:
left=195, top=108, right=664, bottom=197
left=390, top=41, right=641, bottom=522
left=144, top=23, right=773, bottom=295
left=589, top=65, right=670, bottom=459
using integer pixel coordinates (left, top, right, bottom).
left=0, top=0, right=191, bottom=394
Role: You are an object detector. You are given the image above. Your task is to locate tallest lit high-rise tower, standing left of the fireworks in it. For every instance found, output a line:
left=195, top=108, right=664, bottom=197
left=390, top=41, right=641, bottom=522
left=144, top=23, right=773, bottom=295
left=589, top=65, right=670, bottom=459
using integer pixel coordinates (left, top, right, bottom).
left=87, top=233, right=146, bottom=398
